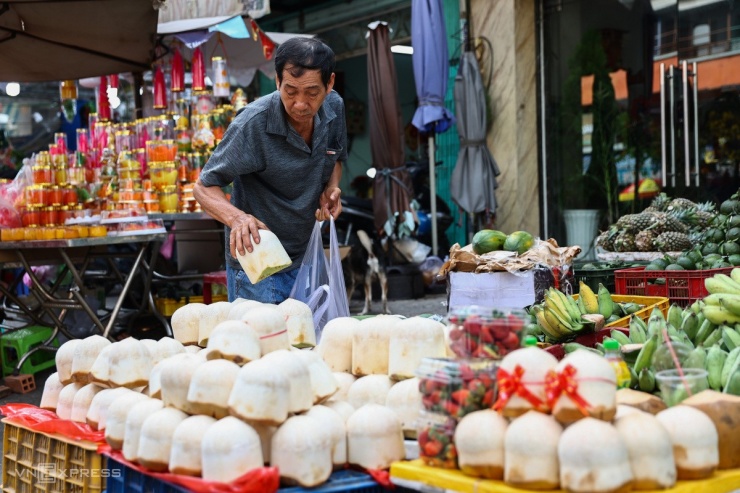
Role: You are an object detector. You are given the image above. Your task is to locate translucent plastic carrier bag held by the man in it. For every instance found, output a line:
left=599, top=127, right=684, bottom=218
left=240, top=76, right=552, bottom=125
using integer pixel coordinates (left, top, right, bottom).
left=290, top=218, right=349, bottom=343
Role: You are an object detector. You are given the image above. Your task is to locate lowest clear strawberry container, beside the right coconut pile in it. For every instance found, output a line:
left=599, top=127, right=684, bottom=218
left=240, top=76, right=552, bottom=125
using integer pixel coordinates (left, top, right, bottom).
left=416, top=412, right=457, bottom=469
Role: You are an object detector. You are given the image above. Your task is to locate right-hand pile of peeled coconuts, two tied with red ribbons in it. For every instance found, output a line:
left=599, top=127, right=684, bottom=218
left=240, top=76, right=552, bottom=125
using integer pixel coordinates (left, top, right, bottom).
left=454, top=347, right=740, bottom=493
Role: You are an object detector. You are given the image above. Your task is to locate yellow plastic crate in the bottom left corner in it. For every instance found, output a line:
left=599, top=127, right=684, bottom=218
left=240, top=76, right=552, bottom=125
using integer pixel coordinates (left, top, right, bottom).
left=2, top=418, right=107, bottom=493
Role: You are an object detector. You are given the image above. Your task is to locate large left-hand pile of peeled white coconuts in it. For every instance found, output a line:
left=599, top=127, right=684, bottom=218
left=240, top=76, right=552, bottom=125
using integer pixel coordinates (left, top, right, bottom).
left=40, top=299, right=447, bottom=487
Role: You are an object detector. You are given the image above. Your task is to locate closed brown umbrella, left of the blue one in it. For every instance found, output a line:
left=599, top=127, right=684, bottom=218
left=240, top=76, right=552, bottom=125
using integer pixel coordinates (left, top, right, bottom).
left=367, top=23, right=413, bottom=236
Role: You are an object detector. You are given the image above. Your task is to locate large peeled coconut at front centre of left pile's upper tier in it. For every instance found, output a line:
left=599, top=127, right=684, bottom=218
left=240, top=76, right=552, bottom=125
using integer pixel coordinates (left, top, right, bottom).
left=228, top=359, right=291, bottom=425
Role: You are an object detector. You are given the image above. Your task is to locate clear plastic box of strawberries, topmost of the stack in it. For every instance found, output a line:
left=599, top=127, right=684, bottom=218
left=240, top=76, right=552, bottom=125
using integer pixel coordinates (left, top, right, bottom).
left=447, top=306, right=529, bottom=359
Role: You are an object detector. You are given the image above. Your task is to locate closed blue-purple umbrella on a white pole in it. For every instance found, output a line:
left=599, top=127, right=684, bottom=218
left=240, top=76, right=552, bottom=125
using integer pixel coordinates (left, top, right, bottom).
left=411, top=0, right=455, bottom=255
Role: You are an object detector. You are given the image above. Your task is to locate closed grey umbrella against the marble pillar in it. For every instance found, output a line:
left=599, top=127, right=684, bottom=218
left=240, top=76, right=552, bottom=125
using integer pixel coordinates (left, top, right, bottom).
left=450, top=51, right=501, bottom=214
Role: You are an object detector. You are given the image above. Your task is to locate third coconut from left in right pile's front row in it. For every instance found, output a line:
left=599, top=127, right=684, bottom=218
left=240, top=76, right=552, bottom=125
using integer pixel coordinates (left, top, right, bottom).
left=558, top=416, right=634, bottom=493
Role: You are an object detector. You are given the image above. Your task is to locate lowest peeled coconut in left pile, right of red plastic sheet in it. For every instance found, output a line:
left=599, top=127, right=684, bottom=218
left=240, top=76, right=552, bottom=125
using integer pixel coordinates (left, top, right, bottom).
left=270, top=416, right=333, bottom=488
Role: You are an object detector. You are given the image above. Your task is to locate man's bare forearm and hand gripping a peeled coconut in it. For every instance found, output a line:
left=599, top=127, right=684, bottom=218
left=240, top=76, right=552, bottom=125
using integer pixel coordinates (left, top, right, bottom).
left=193, top=182, right=268, bottom=257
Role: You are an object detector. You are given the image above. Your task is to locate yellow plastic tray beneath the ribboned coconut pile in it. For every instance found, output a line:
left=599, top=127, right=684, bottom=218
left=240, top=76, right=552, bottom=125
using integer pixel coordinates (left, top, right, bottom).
left=391, top=460, right=740, bottom=493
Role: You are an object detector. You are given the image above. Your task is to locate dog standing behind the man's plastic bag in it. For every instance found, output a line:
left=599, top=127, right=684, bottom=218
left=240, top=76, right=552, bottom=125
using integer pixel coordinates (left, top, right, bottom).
left=342, top=230, right=390, bottom=315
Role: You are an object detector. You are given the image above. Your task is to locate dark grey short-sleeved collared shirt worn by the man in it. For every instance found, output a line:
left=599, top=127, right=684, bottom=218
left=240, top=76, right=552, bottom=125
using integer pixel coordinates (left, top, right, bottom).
left=200, top=91, right=347, bottom=269
